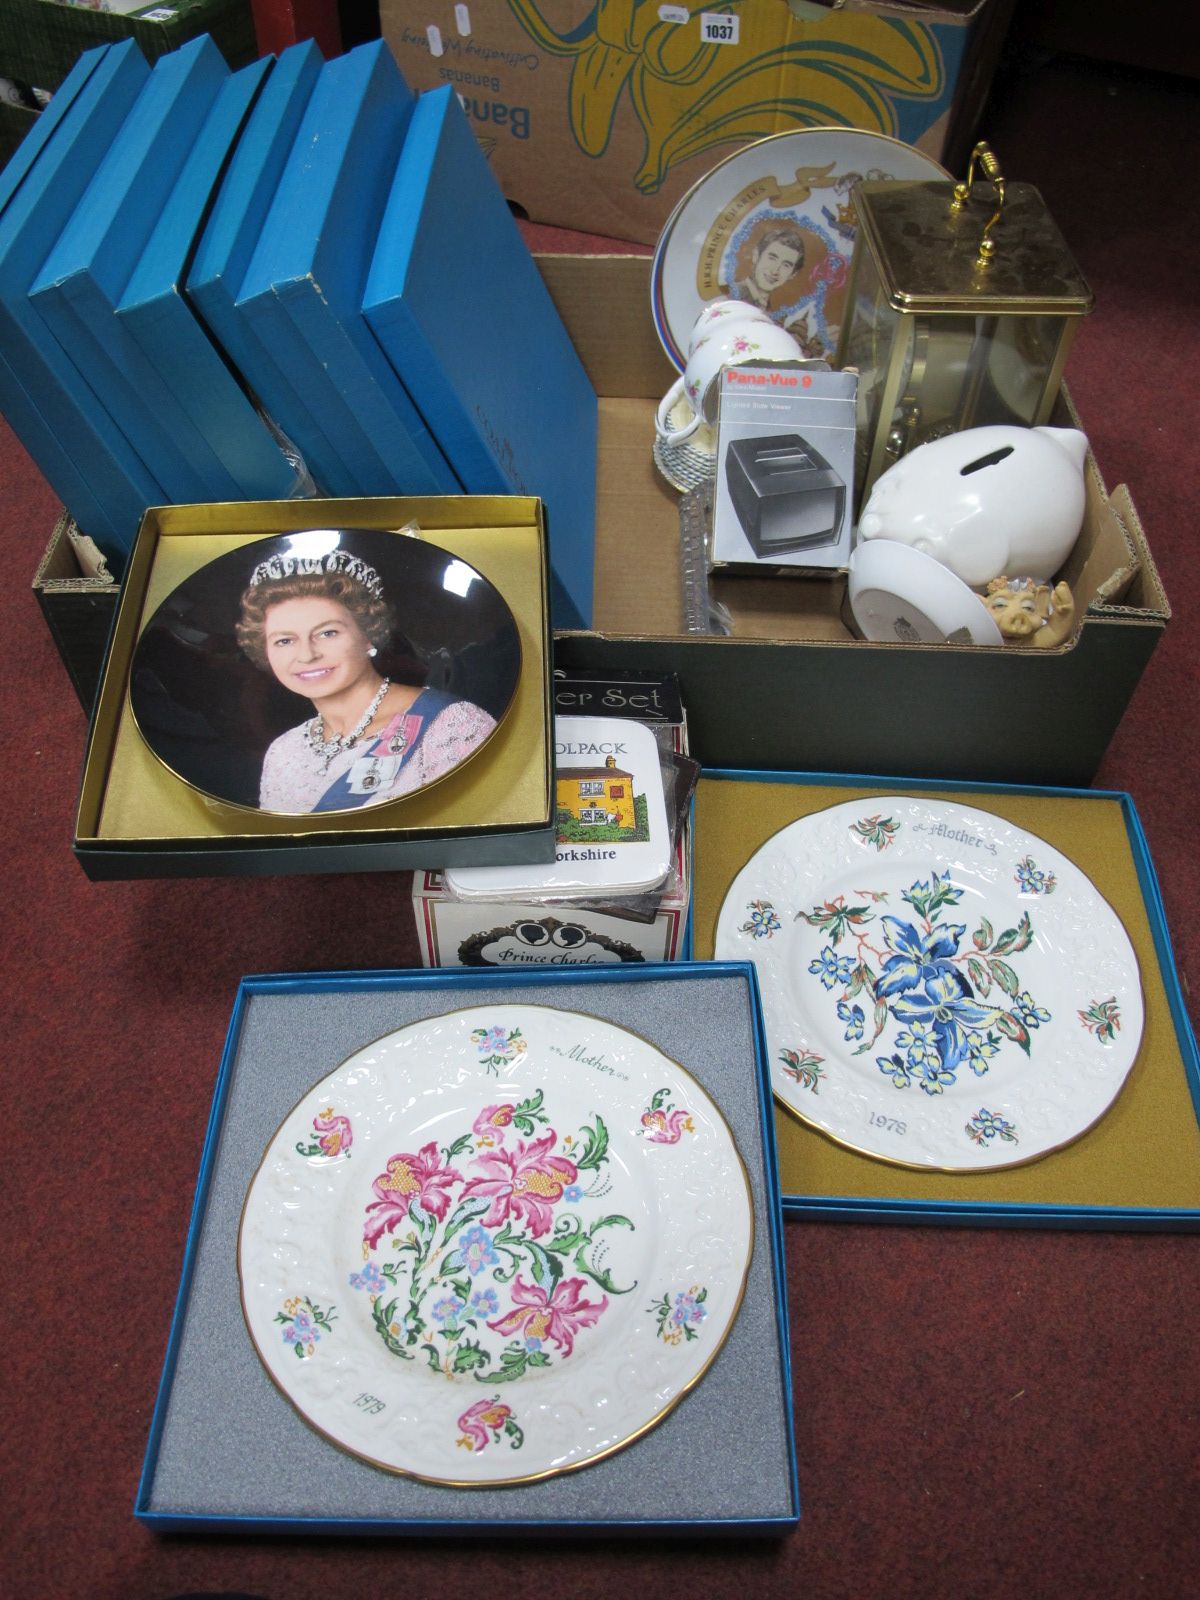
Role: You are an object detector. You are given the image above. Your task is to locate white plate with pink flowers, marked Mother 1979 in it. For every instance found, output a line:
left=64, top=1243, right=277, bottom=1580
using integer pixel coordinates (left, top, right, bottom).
left=238, top=1005, right=754, bottom=1486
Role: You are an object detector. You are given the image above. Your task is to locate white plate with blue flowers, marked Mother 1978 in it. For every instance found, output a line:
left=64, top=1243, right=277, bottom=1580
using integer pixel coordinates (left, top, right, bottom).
left=715, top=795, right=1142, bottom=1173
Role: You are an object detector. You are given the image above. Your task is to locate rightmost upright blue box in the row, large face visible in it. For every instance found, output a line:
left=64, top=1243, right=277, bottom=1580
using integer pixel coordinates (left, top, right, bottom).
left=363, top=86, right=597, bottom=627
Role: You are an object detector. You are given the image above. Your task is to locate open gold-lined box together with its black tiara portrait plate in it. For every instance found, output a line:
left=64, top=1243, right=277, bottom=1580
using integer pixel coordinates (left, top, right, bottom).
left=75, top=496, right=554, bottom=878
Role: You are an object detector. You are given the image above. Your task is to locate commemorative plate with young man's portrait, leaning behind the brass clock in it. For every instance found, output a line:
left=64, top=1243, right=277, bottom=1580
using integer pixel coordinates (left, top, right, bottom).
left=650, top=128, right=949, bottom=371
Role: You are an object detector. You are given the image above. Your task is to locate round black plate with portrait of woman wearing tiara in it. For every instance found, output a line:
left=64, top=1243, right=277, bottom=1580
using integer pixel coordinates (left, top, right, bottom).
left=130, top=528, right=522, bottom=816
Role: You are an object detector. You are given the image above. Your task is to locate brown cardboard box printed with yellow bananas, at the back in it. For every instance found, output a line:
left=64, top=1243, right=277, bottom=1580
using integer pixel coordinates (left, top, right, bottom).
left=379, top=0, right=1013, bottom=245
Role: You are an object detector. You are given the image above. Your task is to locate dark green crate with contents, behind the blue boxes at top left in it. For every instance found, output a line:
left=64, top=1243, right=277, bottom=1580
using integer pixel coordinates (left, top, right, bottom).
left=0, top=0, right=258, bottom=90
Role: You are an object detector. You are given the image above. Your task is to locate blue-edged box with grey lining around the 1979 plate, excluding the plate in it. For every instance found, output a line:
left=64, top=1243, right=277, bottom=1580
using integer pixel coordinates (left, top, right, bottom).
left=138, top=973, right=798, bottom=1533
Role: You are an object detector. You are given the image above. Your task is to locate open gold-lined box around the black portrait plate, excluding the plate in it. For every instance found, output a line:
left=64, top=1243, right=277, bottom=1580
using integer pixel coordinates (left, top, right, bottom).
left=75, top=496, right=555, bottom=878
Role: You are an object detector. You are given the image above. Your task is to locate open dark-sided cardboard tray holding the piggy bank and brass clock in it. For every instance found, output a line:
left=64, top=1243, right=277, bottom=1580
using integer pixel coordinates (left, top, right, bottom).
left=35, top=256, right=1170, bottom=786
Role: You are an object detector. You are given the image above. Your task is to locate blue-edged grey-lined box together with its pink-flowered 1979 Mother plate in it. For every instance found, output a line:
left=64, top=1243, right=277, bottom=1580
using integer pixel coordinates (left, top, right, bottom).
left=136, top=963, right=800, bottom=1538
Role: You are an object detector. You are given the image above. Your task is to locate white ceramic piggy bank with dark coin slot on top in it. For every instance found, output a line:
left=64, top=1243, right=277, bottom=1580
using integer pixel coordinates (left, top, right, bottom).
left=858, top=424, right=1088, bottom=589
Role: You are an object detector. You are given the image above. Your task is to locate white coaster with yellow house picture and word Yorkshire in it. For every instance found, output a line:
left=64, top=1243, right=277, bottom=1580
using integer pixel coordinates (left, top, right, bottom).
left=445, top=717, right=670, bottom=899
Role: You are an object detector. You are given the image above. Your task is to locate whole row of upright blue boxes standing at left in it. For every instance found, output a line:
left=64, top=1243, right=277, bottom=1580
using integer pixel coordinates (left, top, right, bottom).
left=0, top=38, right=597, bottom=627
